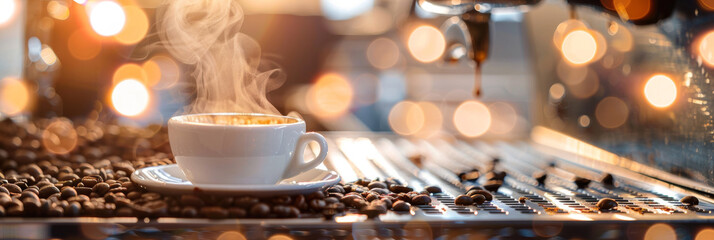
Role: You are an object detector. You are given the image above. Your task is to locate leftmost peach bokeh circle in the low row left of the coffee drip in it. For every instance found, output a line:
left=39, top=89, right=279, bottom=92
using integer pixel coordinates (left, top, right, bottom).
left=389, top=101, right=425, bottom=135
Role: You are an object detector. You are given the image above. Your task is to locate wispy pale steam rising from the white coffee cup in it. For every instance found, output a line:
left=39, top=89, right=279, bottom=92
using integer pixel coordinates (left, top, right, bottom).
left=157, top=0, right=280, bottom=115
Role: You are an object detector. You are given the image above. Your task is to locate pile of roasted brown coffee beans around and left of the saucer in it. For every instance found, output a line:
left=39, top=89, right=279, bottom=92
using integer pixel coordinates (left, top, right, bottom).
left=0, top=119, right=441, bottom=219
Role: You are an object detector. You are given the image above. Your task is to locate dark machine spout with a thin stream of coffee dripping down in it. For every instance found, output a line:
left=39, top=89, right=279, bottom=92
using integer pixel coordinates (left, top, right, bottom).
left=461, top=10, right=491, bottom=97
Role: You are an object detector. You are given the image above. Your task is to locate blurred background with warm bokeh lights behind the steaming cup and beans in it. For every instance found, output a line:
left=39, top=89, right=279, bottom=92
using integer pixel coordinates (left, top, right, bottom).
left=0, top=0, right=714, bottom=185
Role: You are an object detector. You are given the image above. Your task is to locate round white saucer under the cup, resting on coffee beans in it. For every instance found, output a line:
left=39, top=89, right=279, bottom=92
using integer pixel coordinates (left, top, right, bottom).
left=131, top=164, right=340, bottom=197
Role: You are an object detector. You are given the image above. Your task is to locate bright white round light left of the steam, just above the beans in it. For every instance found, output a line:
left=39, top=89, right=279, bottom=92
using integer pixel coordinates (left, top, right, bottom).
left=112, top=79, right=149, bottom=116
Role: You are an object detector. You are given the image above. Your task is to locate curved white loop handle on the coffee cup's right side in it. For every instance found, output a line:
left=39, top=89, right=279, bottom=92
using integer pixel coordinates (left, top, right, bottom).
left=283, top=132, right=327, bottom=179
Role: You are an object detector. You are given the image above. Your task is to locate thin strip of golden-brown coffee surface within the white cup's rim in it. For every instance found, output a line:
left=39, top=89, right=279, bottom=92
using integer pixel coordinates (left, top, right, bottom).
left=175, top=113, right=299, bottom=125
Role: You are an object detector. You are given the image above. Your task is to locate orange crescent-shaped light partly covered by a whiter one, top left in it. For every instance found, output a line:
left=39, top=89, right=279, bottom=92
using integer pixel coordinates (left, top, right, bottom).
left=114, top=5, right=149, bottom=45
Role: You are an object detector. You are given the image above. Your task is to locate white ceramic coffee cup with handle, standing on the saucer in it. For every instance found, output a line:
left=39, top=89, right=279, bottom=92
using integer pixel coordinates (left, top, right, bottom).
left=168, top=113, right=327, bottom=185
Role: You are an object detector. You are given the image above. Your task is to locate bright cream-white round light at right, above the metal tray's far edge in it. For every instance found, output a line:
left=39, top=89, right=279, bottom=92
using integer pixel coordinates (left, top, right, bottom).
left=645, top=74, right=677, bottom=108
